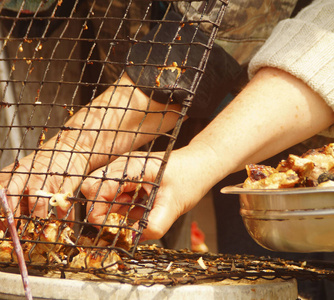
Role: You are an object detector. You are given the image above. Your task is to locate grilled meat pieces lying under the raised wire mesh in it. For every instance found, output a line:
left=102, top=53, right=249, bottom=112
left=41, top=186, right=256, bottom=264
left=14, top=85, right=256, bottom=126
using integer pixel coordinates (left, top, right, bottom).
left=0, top=213, right=132, bottom=271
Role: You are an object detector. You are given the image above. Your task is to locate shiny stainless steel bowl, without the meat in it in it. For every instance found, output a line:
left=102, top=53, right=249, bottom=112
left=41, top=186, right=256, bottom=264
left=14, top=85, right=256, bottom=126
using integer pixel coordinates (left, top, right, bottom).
left=221, top=184, right=334, bottom=253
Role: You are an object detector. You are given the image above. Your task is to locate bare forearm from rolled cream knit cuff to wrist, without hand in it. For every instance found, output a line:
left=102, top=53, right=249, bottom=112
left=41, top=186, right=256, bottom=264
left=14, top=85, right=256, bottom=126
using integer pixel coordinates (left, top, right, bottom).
left=188, top=68, right=334, bottom=189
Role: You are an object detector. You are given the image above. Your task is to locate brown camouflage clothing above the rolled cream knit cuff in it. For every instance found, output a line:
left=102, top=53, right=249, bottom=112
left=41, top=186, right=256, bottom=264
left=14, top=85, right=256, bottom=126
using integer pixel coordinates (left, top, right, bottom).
left=176, top=0, right=298, bottom=65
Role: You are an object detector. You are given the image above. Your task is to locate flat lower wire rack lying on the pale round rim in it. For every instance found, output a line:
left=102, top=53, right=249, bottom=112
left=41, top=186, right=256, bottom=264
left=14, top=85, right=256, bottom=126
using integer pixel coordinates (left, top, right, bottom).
left=2, top=245, right=334, bottom=287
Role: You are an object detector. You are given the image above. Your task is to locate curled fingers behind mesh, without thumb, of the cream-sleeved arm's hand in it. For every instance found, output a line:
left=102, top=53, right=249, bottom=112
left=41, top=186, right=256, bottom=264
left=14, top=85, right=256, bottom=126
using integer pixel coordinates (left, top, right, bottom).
left=81, top=154, right=158, bottom=222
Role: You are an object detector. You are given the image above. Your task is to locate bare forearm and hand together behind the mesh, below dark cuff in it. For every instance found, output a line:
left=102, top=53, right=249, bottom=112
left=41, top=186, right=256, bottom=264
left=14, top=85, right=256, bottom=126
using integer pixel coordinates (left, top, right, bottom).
left=0, top=75, right=183, bottom=221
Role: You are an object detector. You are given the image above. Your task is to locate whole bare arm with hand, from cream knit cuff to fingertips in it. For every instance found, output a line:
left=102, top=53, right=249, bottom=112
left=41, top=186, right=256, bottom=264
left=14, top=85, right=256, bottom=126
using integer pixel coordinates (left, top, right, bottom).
left=82, top=69, right=334, bottom=239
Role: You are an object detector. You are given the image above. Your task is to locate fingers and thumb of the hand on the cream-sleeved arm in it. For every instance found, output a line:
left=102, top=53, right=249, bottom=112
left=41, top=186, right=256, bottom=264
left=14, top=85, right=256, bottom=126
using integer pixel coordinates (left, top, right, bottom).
left=81, top=151, right=182, bottom=241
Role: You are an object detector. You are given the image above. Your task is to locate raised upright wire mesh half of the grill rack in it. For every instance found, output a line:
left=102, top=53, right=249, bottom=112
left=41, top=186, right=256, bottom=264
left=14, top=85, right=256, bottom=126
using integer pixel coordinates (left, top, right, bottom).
left=0, top=0, right=227, bottom=272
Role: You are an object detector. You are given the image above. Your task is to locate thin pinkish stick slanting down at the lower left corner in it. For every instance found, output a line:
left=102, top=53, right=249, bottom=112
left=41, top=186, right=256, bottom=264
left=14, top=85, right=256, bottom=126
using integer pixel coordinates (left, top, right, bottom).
left=0, top=188, right=32, bottom=300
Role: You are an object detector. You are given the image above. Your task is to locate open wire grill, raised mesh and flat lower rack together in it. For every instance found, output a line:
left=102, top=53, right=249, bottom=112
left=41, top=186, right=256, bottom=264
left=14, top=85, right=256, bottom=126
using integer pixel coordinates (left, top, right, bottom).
left=0, top=0, right=332, bottom=299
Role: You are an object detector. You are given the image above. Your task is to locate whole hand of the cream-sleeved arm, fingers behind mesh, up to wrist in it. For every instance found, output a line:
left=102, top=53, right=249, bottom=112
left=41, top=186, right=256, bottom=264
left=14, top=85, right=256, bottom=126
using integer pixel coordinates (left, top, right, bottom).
left=81, top=147, right=214, bottom=241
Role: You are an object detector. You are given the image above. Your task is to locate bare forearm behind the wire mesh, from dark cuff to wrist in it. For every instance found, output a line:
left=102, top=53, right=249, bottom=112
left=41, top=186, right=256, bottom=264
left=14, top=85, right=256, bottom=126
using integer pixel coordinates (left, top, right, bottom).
left=51, top=75, right=179, bottom=171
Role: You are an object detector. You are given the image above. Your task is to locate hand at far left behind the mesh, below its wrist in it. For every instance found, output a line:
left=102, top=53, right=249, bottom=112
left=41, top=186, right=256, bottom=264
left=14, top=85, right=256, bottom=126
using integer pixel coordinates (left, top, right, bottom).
left=0, top=138, right=87, bottom=219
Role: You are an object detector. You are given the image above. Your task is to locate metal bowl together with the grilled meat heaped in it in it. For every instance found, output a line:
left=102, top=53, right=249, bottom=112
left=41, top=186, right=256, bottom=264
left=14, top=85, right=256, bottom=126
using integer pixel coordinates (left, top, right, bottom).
left=221, top=143, right=334, bottom=253
